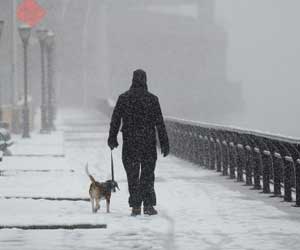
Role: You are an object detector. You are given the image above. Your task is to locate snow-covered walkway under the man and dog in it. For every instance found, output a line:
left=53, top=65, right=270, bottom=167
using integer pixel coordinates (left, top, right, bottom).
left=0, top=111, right=300, bottom=250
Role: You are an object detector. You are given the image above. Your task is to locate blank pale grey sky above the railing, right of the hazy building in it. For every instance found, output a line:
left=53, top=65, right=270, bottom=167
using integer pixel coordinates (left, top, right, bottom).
left=216, top=0, right=300, bottom=138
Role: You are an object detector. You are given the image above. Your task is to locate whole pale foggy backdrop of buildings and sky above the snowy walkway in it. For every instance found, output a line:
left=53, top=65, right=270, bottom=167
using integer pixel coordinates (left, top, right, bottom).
left=0, top=0, right=300, bottom=137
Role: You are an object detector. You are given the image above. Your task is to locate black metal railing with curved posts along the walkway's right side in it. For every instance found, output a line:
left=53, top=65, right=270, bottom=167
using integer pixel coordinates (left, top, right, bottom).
left=165, top=118, right=300, bottom=206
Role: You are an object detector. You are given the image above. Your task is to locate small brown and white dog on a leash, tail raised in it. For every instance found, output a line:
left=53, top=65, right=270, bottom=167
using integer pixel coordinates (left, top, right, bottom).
left=85, top=164, right=120, bottom=213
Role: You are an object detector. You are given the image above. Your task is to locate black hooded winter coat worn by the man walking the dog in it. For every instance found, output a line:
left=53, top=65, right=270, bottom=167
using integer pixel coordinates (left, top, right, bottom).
left=108, top=70, right=169, bottom=160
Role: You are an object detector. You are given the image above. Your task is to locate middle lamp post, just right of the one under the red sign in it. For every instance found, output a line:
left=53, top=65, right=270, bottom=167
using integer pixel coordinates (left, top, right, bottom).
left=36, top=29, right=49, bottom=133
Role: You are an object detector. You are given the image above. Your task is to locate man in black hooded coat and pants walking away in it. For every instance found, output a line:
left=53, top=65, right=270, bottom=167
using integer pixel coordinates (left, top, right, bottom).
left=108, top=69, right=169, bottom=215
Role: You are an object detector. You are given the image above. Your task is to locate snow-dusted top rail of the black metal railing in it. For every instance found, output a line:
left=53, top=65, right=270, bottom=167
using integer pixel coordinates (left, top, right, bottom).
left=165, top=116, right=300, bottom=144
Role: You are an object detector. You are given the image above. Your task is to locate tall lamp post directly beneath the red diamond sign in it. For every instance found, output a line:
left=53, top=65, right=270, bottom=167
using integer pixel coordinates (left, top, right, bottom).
left=19, top=25, right=31, bottom=138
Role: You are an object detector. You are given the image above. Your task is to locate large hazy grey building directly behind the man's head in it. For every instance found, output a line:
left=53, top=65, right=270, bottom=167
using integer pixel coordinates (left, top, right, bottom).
left=107, top=0, right=242, bottom=122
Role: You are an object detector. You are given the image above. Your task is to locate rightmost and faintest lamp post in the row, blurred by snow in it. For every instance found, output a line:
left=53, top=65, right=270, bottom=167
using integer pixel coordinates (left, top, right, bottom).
left=46, top=31, right=55, bottom=130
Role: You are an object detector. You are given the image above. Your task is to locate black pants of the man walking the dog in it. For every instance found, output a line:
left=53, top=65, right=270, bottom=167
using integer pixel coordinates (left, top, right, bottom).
left=123, top=156, right=156, bottom=207
